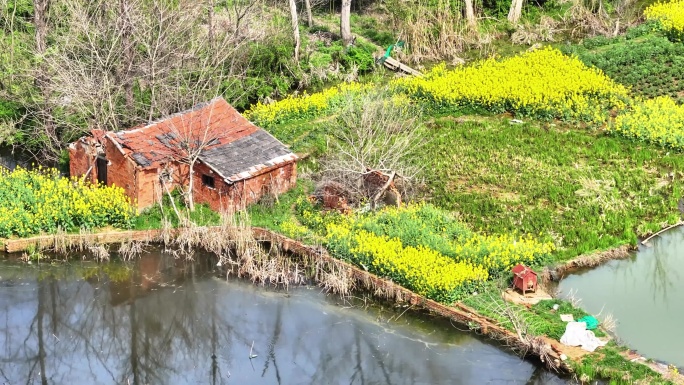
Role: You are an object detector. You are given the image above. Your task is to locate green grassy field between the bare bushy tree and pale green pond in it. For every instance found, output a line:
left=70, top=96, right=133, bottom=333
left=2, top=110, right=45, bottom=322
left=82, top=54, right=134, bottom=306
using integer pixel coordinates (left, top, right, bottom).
left=424, top=117, right=684, bottom=260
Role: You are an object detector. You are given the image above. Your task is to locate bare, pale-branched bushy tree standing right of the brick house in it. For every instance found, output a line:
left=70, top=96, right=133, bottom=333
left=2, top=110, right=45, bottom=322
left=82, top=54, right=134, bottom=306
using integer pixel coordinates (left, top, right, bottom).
left=322, top=91, right=426, bottom=206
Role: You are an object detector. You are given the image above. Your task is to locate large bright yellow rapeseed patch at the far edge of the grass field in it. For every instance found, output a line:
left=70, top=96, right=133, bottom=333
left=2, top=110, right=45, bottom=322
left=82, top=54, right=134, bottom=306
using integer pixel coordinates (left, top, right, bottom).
left=393, top=48, right=627, bottom=121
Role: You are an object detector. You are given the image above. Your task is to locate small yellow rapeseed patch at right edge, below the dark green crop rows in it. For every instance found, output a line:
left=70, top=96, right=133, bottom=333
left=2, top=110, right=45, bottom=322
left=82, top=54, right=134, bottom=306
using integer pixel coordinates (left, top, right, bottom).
left=610, top=96, right=684, bottom=150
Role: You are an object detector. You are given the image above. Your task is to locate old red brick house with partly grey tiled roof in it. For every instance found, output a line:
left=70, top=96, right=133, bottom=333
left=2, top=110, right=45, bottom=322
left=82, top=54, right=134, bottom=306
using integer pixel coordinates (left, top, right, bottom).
left=69, top=98, right=297, bottom=211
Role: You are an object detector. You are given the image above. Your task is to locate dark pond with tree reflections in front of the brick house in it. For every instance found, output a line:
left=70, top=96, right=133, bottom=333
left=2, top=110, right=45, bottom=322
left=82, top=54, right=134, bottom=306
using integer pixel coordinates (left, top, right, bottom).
left=0, top=253, right=566, bottom=385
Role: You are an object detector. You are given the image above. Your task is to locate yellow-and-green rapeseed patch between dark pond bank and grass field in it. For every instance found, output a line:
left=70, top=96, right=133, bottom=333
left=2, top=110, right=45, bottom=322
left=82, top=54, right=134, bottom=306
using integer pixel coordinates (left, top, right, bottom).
left=318, top=204, right=555, bottom=303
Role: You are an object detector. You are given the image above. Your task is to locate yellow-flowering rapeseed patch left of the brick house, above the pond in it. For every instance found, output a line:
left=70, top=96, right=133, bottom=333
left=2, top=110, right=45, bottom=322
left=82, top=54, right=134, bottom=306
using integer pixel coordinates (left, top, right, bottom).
left=0, top=168, right=134, bottom=237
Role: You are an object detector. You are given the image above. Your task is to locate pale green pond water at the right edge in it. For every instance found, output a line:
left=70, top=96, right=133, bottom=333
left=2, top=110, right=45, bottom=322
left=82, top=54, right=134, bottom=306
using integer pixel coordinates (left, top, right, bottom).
left=559, top=227, right=684, bottom=367
